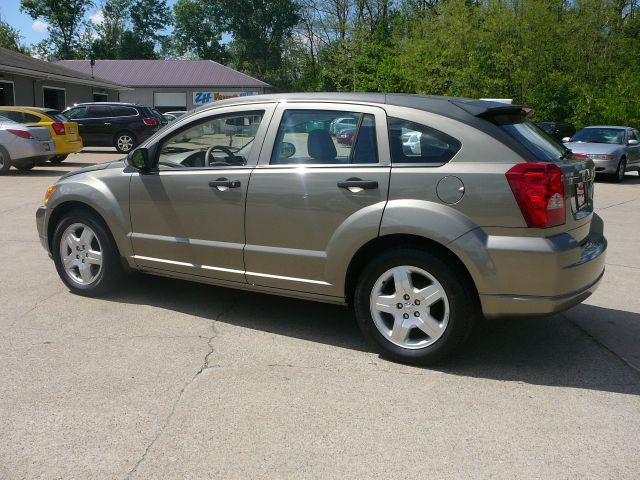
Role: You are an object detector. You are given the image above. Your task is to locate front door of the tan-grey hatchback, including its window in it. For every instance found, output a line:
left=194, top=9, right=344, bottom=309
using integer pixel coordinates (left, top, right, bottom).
left=130, top=103, right=275, bottom=283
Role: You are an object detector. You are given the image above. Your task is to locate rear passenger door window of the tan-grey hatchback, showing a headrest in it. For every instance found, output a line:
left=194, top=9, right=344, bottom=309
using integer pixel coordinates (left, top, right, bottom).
left=271, top=110, right=378, bottom=165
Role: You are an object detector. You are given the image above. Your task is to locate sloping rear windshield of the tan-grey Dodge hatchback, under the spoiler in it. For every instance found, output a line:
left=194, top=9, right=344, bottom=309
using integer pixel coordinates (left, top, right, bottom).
left=491, top=115, right=566, bottom=162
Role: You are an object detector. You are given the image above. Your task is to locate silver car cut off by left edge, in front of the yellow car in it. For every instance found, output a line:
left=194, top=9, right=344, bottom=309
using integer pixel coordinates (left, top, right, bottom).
left=0, top=117, right=56, bottom=175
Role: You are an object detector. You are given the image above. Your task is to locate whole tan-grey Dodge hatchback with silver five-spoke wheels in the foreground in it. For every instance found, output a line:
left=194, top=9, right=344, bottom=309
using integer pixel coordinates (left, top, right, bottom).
left=36, top=94, right=607, bottom=364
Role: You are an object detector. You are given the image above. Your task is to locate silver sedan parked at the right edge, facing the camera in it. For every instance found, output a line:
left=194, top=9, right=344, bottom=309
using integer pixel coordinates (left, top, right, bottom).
left=562, top=126, right=640, bottom=182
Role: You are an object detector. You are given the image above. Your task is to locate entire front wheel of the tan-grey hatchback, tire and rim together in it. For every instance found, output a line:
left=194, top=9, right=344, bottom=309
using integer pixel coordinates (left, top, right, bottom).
left=51, top=210, right=123, bottom=296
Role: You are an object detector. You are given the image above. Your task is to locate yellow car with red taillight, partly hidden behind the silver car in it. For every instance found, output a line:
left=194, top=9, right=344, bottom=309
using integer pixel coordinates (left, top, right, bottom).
left=0, top=107, right=83, bottom=163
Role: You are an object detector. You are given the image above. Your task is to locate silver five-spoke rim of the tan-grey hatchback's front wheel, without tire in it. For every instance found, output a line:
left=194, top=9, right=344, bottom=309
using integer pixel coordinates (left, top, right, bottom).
left=60, top=223, right=103, bottom=285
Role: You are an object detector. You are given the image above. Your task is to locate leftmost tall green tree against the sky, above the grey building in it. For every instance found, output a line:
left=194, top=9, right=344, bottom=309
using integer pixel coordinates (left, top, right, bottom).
left=20, top=0, right=93, bottom=59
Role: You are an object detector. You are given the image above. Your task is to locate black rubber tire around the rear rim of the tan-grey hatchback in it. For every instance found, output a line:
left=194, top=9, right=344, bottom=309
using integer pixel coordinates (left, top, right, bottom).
left=354, top=248, right=481, bottom=365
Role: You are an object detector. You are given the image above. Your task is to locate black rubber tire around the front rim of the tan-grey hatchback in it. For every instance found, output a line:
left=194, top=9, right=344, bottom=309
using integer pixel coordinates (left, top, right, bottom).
left=51, top=209, right=124, bottom=297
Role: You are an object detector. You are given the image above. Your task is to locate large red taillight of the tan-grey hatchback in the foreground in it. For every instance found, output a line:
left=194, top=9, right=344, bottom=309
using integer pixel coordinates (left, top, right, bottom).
left=506, top=163, right=565, bottom=228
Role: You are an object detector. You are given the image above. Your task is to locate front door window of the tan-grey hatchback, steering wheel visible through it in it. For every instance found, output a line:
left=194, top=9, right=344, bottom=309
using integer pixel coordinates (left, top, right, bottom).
left=158, top=110, right=264, bottom=170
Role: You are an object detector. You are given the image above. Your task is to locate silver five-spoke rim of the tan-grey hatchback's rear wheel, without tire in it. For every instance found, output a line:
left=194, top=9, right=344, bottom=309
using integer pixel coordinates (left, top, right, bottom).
left=369, top=265, right=450, bottom=350
